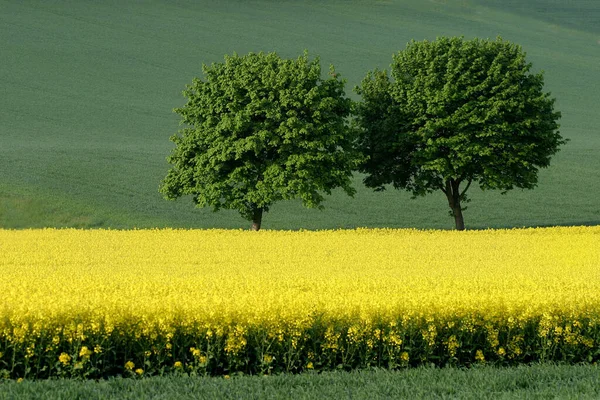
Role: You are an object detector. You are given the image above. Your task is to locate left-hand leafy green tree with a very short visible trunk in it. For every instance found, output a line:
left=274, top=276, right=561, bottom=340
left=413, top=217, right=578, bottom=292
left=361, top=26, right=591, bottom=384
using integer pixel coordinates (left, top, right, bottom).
left=159, top=52, right=361, bottom=230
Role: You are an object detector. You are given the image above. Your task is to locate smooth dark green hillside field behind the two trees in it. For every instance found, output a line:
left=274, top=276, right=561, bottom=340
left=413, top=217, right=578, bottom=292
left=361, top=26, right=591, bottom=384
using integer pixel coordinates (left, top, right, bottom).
left=0, top=0, right=600, bottom=229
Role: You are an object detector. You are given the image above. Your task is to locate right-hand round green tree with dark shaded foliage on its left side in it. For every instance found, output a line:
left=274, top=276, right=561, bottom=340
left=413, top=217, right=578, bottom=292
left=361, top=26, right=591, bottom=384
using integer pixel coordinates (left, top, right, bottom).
left=355, top=38, right=566, bottom=230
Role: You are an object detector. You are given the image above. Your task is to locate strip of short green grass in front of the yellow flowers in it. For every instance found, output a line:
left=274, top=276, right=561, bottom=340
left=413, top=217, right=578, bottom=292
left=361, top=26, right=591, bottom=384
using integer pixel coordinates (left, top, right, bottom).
left=0, top=364, right=600, bottom=399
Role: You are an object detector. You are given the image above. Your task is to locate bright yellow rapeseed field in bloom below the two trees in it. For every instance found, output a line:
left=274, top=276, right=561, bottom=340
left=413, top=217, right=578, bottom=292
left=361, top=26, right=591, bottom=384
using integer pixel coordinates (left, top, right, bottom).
left=0, top=227, right=600, bottom=377
